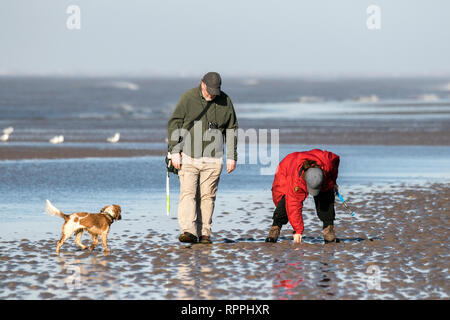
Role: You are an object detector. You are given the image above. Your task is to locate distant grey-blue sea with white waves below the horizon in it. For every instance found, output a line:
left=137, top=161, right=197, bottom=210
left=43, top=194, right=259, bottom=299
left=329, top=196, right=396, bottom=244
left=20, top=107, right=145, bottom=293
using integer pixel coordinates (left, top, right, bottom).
left=0, top=77, right=450, bottom=142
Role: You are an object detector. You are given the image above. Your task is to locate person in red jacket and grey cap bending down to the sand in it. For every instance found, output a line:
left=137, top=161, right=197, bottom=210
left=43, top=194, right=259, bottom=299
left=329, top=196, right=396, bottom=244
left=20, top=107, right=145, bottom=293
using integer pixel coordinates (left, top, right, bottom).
left=266, top=149, right=340, bottom=243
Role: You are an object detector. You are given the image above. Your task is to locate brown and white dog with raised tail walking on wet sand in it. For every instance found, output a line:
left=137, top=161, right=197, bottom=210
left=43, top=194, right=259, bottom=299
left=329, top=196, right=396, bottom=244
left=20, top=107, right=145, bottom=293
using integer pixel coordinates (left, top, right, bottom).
left=46, top=200, right=122, bottom=254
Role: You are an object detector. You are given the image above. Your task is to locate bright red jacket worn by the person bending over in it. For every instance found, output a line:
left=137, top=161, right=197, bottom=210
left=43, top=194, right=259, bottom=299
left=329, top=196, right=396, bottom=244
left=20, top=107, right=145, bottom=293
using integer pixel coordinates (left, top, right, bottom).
left=272, top=149, right=340, bottom=234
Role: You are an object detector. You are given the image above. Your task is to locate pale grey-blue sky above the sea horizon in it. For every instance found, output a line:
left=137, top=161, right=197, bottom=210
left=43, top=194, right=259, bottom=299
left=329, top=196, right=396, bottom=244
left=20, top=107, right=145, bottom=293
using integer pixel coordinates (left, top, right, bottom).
left=0, top=0, right=450, bottom=77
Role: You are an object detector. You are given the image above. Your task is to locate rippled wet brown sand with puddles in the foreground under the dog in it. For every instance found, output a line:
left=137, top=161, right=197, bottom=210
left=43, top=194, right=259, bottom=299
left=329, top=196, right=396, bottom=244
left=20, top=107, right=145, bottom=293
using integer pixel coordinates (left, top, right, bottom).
left=0, top=184, right=450, bottom=299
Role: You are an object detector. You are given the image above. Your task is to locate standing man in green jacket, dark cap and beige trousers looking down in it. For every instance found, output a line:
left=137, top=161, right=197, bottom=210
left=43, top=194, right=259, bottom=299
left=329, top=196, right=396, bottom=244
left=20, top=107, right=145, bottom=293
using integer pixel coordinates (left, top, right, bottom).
left=168, top=72, right=238, bottom=243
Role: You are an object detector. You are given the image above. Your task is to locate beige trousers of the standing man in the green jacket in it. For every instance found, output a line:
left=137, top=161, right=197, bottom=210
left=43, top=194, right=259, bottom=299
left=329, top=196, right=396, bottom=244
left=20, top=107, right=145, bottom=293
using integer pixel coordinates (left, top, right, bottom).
left=178, top=154, right=222, bottom=237
